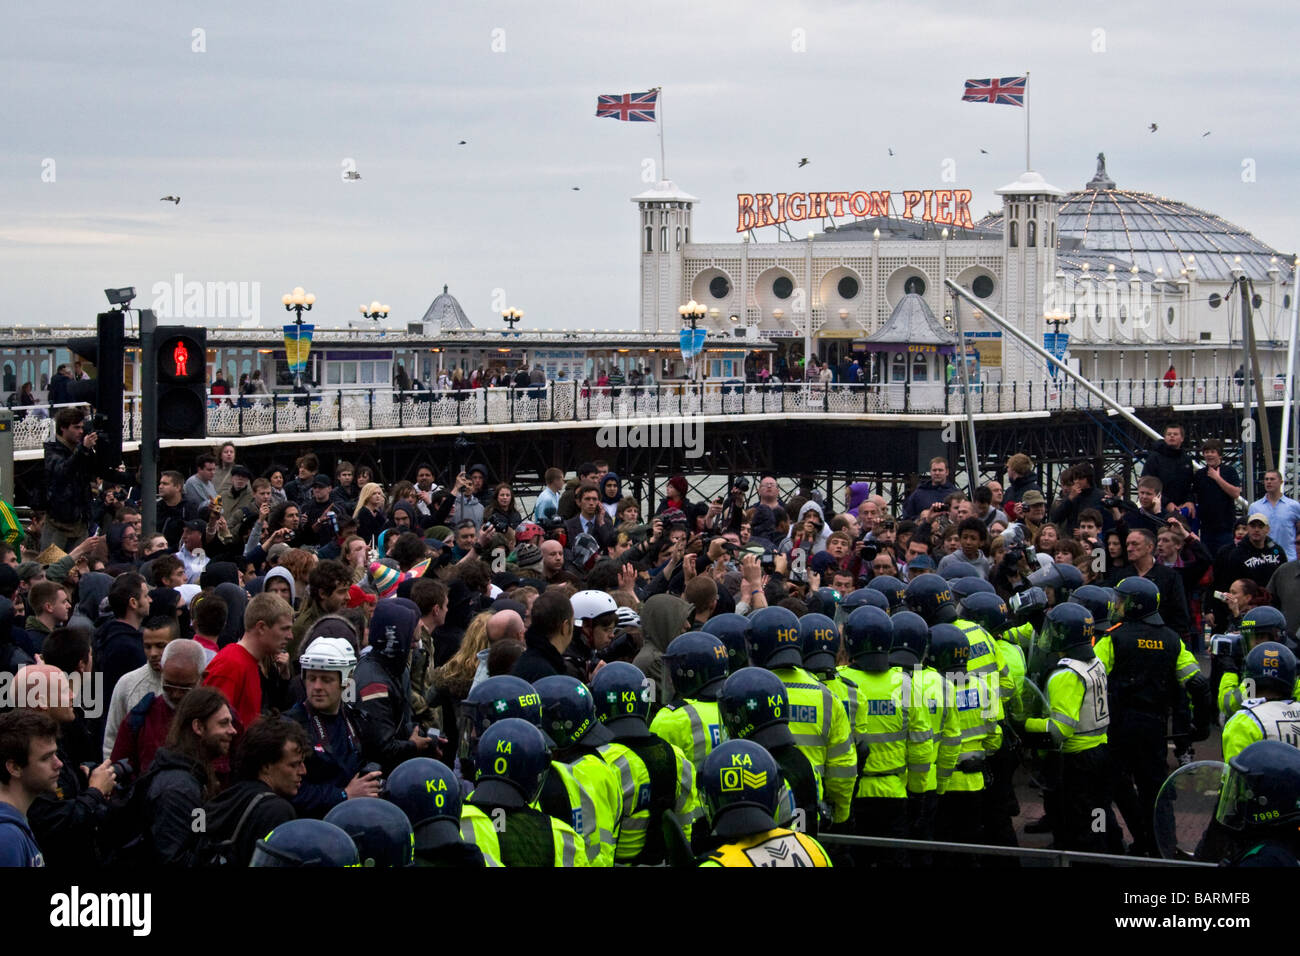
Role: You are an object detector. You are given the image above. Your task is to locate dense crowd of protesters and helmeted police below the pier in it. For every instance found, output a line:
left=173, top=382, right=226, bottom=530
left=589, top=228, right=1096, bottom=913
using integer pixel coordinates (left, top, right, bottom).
left=0, top=410, right=1300, bottom=866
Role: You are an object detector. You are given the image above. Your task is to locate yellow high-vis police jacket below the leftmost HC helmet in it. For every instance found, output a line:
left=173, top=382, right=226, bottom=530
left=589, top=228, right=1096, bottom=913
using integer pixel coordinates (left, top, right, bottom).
left=772, top=667, right=858, bottom=823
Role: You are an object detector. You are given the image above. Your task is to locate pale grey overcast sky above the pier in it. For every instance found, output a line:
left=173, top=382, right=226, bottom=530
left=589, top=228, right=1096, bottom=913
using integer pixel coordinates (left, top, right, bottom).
left=0, top=0, right=1300, bottom=328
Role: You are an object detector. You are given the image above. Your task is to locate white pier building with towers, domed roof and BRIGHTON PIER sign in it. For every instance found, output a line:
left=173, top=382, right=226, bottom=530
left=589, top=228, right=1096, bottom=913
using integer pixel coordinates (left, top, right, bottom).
left=633, top=155, right=1295, bottom=389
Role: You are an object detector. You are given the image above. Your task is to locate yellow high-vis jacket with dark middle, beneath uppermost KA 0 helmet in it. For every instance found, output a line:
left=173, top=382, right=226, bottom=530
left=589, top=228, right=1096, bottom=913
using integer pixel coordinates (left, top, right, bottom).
left=597, top=737, right=703, bottom=864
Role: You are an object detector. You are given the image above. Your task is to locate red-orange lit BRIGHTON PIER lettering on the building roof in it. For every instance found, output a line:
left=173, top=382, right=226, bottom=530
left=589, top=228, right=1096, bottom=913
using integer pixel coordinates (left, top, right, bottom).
left=736, top=189, right=975, bottom=233
